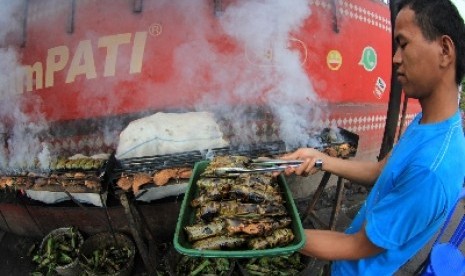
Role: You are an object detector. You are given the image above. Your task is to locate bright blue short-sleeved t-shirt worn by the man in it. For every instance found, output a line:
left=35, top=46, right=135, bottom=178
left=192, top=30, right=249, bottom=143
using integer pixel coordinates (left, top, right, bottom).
left=332, top=109, right=465, bottom=276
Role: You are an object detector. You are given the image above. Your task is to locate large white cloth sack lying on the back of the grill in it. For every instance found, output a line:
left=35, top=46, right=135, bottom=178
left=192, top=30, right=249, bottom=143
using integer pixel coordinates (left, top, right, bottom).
left=116, top=112, right=228, bottom=159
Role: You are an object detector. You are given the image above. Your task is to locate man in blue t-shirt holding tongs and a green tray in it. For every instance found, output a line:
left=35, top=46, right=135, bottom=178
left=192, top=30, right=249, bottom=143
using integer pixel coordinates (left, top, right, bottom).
left=283, top=0, right=465, bottom=275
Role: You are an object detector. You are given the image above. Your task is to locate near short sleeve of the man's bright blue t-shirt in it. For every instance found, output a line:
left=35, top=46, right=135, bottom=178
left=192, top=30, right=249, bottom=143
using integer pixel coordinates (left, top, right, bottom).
left=365, top=167, right=447, bottom=249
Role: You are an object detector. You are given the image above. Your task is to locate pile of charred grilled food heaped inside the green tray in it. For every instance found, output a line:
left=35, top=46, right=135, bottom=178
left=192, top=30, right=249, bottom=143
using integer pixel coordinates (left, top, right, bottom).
left=184, top=156, right=294, bottom=250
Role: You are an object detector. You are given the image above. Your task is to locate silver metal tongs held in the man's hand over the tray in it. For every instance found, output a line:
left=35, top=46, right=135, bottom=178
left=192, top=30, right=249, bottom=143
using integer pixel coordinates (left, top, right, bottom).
left=215, top=158, right=303, bottom=176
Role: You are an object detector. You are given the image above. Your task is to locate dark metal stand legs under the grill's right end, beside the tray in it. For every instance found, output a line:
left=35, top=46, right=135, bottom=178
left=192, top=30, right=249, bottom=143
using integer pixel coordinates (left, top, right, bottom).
left=302, top=172, right=344, bottom=230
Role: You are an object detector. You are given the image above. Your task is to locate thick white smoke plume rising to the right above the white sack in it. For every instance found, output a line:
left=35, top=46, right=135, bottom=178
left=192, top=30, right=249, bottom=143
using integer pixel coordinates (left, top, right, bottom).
left=190, top=0, right=322, bottom=147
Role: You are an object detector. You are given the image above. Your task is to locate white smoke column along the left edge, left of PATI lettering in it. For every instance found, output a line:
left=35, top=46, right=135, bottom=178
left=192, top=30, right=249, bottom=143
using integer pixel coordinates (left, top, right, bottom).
left=0, top=0, right=49, bottom=169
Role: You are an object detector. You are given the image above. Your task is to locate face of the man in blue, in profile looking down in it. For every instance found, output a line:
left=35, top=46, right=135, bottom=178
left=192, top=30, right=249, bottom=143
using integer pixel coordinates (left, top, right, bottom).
left=393, top=8, right=442, bottom=99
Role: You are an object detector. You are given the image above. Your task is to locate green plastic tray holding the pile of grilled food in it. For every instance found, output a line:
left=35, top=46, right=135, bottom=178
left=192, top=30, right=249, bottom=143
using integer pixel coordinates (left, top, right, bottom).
left=174, top=161, right=305, bottom=258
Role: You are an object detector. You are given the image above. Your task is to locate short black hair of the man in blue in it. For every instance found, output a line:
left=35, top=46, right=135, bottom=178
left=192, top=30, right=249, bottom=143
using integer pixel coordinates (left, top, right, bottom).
left=397, top=0, right=465, bottom=84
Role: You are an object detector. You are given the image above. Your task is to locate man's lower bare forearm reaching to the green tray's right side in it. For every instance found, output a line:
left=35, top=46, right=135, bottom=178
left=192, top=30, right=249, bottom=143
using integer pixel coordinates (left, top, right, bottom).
left=300, top=224, right=384, bottom=261
